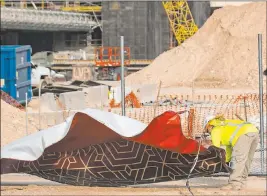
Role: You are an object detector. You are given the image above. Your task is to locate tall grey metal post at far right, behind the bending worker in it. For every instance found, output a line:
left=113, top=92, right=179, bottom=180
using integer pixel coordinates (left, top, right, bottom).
left=258, top=34, right=264, bottom=173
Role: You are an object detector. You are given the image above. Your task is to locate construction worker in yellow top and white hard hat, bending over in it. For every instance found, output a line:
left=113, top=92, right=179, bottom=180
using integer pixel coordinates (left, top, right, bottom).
left=204, top=115, right=259, bottom=190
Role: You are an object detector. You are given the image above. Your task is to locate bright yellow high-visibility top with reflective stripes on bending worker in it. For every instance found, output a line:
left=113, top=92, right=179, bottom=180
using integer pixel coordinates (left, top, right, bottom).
left=211, top=120, right=259, bottom=162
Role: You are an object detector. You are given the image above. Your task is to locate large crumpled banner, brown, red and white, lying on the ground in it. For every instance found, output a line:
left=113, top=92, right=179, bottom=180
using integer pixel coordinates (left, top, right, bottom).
left=1, top=109, right=229, bottom=186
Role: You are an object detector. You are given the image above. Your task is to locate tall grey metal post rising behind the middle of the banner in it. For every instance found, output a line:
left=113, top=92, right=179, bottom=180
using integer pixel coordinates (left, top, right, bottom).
left=121, top=36, right=125, bottom=116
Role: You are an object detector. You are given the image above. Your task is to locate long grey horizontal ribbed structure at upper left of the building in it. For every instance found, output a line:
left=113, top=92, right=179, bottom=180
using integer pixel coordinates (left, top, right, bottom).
left=1, top=7, right=99, bottom=32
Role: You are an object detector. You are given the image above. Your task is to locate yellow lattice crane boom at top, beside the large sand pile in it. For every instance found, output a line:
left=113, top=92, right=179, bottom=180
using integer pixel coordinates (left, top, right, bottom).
left=162, top=0, right=198, bottom=45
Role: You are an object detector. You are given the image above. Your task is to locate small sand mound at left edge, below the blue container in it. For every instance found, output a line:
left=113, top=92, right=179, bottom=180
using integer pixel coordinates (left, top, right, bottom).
left=1, top=100, right=37, bottom=147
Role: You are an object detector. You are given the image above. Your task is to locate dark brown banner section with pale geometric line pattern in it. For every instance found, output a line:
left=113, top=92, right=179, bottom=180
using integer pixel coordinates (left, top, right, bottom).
left=2, top=139, right=228, bottom=187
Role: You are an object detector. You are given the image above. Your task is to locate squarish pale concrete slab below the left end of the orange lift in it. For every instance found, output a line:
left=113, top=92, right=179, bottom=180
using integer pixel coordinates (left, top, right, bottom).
left=83, top=85, right=109, bottom=108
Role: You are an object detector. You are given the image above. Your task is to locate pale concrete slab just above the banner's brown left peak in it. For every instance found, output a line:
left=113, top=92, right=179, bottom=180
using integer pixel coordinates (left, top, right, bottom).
left=59, top=91, right=86, bottom=110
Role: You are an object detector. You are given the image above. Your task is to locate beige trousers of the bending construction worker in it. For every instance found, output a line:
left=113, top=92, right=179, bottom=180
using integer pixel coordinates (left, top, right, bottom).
left=229, top=133, right=259, bottom=185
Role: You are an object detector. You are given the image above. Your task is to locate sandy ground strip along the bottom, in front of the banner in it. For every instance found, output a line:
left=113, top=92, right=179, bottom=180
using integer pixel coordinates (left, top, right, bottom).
left=1, top=174, right=266, bottom=196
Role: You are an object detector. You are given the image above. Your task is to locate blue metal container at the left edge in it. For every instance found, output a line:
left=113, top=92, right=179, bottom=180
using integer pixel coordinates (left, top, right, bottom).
left=1, top=45, right=32, bottom=104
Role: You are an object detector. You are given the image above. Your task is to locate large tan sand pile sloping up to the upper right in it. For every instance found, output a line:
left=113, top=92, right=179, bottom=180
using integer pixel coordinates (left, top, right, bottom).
left=126, top=2, right=266, bottom=89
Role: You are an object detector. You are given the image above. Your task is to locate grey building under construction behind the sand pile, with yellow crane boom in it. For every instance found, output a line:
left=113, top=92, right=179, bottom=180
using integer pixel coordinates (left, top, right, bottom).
left=1, top=0, right=243, bottom=79
